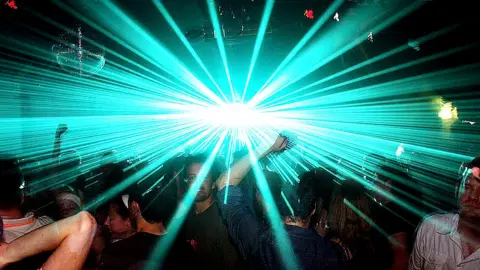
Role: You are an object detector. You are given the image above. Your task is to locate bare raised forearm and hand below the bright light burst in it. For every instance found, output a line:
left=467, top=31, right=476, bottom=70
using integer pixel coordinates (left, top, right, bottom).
left=217, top=134, right=289, bottom=190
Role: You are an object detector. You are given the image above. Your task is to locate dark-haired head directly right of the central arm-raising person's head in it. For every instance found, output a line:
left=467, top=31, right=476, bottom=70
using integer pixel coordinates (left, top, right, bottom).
left=327, top=180, right=371, bottom=245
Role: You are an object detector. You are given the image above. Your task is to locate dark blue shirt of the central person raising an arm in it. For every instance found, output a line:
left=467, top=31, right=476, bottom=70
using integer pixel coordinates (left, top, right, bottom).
left=217, top=186, right=346, bottom=270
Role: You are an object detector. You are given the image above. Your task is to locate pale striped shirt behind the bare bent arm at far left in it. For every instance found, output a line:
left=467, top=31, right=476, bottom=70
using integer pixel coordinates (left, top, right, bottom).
left=3, top=213, right=53, bottom=243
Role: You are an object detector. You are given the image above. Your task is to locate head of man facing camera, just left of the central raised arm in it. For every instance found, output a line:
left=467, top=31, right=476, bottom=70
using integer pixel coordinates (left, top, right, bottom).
left=185, top=155, right=223, bottom=202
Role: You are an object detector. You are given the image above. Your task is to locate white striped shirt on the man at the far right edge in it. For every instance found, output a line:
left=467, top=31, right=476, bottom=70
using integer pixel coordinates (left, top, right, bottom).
left=408, top=213, right=480, bottom=270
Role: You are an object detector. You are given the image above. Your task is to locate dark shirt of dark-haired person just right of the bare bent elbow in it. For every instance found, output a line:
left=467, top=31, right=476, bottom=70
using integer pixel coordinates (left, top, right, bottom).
left=100, top=232, right=195, bottom=270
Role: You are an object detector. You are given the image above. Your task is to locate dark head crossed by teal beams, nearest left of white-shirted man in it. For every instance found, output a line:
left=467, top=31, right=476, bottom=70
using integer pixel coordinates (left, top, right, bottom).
left=374, top=163, right=421, bottom=204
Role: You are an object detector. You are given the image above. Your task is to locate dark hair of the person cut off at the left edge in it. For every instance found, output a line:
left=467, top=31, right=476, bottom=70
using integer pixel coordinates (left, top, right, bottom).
left=0, top=159, right=23, bottom=209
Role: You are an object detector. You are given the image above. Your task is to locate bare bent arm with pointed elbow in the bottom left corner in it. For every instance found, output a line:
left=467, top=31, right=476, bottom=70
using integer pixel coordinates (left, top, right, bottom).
left=0, top=212, right=96, bottom=270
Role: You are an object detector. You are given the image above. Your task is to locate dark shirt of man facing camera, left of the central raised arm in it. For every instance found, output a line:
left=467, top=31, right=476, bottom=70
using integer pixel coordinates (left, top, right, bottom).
left=186, top=202, right=245, bottom=269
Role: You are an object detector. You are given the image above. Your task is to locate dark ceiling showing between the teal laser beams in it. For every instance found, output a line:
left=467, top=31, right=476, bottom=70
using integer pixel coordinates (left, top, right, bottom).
left=0, top=0, right=480, bottom=104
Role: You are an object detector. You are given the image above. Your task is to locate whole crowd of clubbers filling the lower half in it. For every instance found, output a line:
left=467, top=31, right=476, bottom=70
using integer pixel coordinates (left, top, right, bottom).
left=0, top=125, right=480, bottom=270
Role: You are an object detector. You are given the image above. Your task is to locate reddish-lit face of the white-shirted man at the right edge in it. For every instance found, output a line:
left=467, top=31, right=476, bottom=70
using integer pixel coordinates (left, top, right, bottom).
left=459, top=167, right=480, bottom=221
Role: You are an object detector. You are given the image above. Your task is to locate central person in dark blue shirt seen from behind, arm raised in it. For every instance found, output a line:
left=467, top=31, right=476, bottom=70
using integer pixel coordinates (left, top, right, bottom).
left=216, top=134, right=346, bottom=270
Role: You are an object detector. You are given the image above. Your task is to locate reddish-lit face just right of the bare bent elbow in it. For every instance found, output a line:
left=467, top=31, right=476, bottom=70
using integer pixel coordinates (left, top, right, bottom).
left=105, top=197, right=135, bottom=239
